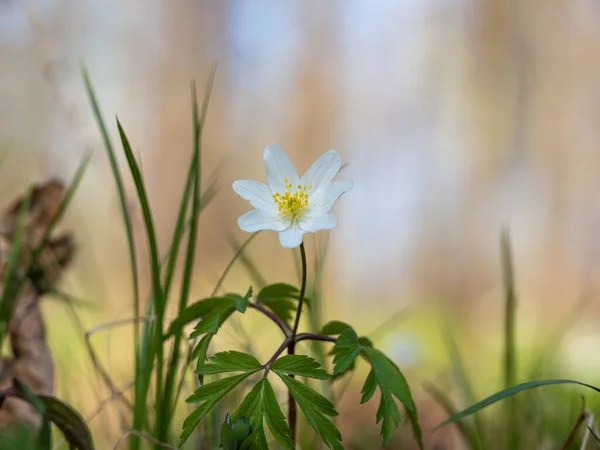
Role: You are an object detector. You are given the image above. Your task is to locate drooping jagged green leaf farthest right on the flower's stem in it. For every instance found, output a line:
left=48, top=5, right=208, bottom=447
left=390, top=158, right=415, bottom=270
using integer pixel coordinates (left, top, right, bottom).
left=361, top=347, right=423, bottom=449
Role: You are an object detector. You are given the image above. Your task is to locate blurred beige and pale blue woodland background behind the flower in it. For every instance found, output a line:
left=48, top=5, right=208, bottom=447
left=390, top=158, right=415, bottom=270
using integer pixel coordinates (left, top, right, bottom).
left=0, top=0, right=600, bottom=448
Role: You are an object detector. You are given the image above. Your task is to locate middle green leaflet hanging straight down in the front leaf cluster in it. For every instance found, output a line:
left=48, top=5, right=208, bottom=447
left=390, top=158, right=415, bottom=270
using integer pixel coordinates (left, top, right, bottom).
left=234, top=378, right=294, bottom=450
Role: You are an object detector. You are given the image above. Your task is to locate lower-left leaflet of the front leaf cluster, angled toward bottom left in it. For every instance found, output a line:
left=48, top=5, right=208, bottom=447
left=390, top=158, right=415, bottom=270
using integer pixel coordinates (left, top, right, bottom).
left=179, top=370, right=256, bottom=447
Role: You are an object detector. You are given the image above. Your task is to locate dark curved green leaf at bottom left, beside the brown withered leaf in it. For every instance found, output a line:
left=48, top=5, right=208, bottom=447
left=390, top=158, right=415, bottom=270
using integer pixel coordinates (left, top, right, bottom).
left=39, top=395, right=94, bottom=450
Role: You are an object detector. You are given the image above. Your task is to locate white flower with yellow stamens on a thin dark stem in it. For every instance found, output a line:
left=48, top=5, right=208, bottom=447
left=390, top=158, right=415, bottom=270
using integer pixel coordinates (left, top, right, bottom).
left=233, top=145, right=352, bottom=248
